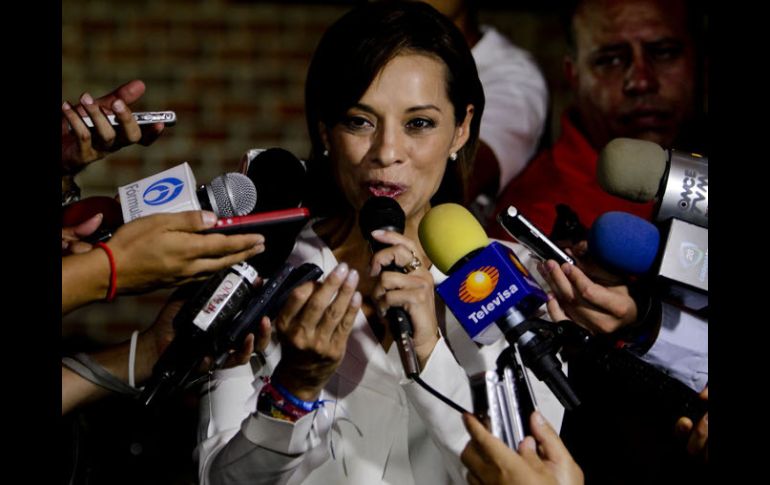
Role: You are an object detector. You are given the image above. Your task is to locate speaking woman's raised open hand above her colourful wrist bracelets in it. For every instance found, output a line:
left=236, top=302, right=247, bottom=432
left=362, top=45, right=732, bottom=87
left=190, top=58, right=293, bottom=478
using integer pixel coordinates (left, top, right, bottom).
left=272, top=263, right=361, bottom=401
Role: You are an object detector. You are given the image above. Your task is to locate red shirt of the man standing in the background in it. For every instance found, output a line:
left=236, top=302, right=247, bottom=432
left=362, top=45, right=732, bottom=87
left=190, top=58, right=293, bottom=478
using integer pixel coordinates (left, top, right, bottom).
left=488, top=109, right=654, bottom=240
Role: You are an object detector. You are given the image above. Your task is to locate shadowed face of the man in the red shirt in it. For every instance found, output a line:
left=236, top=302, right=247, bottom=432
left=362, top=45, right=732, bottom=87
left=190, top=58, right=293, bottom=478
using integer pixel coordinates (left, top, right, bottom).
left=565, top=0, right=695, bottom=149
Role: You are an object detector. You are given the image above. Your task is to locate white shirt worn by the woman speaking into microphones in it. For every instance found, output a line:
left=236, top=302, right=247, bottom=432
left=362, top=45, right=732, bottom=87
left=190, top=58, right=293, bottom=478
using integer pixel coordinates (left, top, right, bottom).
left=196, top=225, right=563, bottom=485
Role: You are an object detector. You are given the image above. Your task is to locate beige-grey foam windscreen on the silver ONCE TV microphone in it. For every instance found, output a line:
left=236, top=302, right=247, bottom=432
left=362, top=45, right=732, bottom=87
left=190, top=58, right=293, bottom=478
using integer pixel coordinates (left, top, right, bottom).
left=596, top=138, right=668, bottom=202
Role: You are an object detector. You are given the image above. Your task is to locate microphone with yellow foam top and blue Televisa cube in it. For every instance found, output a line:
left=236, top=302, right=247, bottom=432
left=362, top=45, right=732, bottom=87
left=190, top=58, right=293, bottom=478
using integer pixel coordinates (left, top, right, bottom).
left=419, top=204, right=580, bottom=409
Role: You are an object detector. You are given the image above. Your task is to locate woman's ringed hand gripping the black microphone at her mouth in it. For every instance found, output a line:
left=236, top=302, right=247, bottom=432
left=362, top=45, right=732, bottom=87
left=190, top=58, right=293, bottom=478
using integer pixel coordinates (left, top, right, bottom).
left=370, top=230, right=439, bottom=367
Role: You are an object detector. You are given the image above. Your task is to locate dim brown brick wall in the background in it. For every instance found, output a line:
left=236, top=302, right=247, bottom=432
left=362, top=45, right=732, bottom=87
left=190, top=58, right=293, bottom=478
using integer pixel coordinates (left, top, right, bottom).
left=62, top=0, right=564, bottom=343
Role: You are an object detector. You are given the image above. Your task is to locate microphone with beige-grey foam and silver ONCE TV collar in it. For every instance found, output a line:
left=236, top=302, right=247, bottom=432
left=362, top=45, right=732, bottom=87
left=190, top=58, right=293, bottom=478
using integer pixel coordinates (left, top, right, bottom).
left=596, top=138, right=708, bottom=228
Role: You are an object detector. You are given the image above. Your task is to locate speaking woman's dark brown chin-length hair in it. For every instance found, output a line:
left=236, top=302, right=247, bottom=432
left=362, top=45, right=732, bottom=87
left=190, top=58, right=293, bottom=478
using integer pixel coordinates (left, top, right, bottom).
left=305, top=1, right=484, bottom=215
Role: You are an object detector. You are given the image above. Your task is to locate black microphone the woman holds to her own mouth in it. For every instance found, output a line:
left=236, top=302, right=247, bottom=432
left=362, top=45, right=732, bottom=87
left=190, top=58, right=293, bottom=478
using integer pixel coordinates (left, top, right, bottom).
left=358, top=197, right=420, bottom=377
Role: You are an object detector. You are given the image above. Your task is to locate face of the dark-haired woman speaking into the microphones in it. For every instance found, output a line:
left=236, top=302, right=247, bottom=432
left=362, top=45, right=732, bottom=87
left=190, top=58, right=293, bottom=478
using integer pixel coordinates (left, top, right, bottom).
left=321, top=54, right=473, bottom=218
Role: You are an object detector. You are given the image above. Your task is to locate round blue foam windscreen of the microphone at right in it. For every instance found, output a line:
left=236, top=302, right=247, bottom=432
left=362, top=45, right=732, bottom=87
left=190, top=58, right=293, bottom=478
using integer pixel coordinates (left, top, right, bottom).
left=588, top=211, right=660, bottom=275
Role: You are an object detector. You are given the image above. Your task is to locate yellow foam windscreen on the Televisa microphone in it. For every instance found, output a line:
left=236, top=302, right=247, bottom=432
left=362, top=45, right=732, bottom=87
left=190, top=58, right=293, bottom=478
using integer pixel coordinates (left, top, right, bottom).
left=418, top=203, right=489, bottom=274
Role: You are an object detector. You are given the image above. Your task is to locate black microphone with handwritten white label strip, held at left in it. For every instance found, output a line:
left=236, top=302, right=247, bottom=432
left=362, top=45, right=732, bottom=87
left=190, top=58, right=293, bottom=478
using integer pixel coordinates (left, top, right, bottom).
left=139, top=262, right=257, bottom=406
